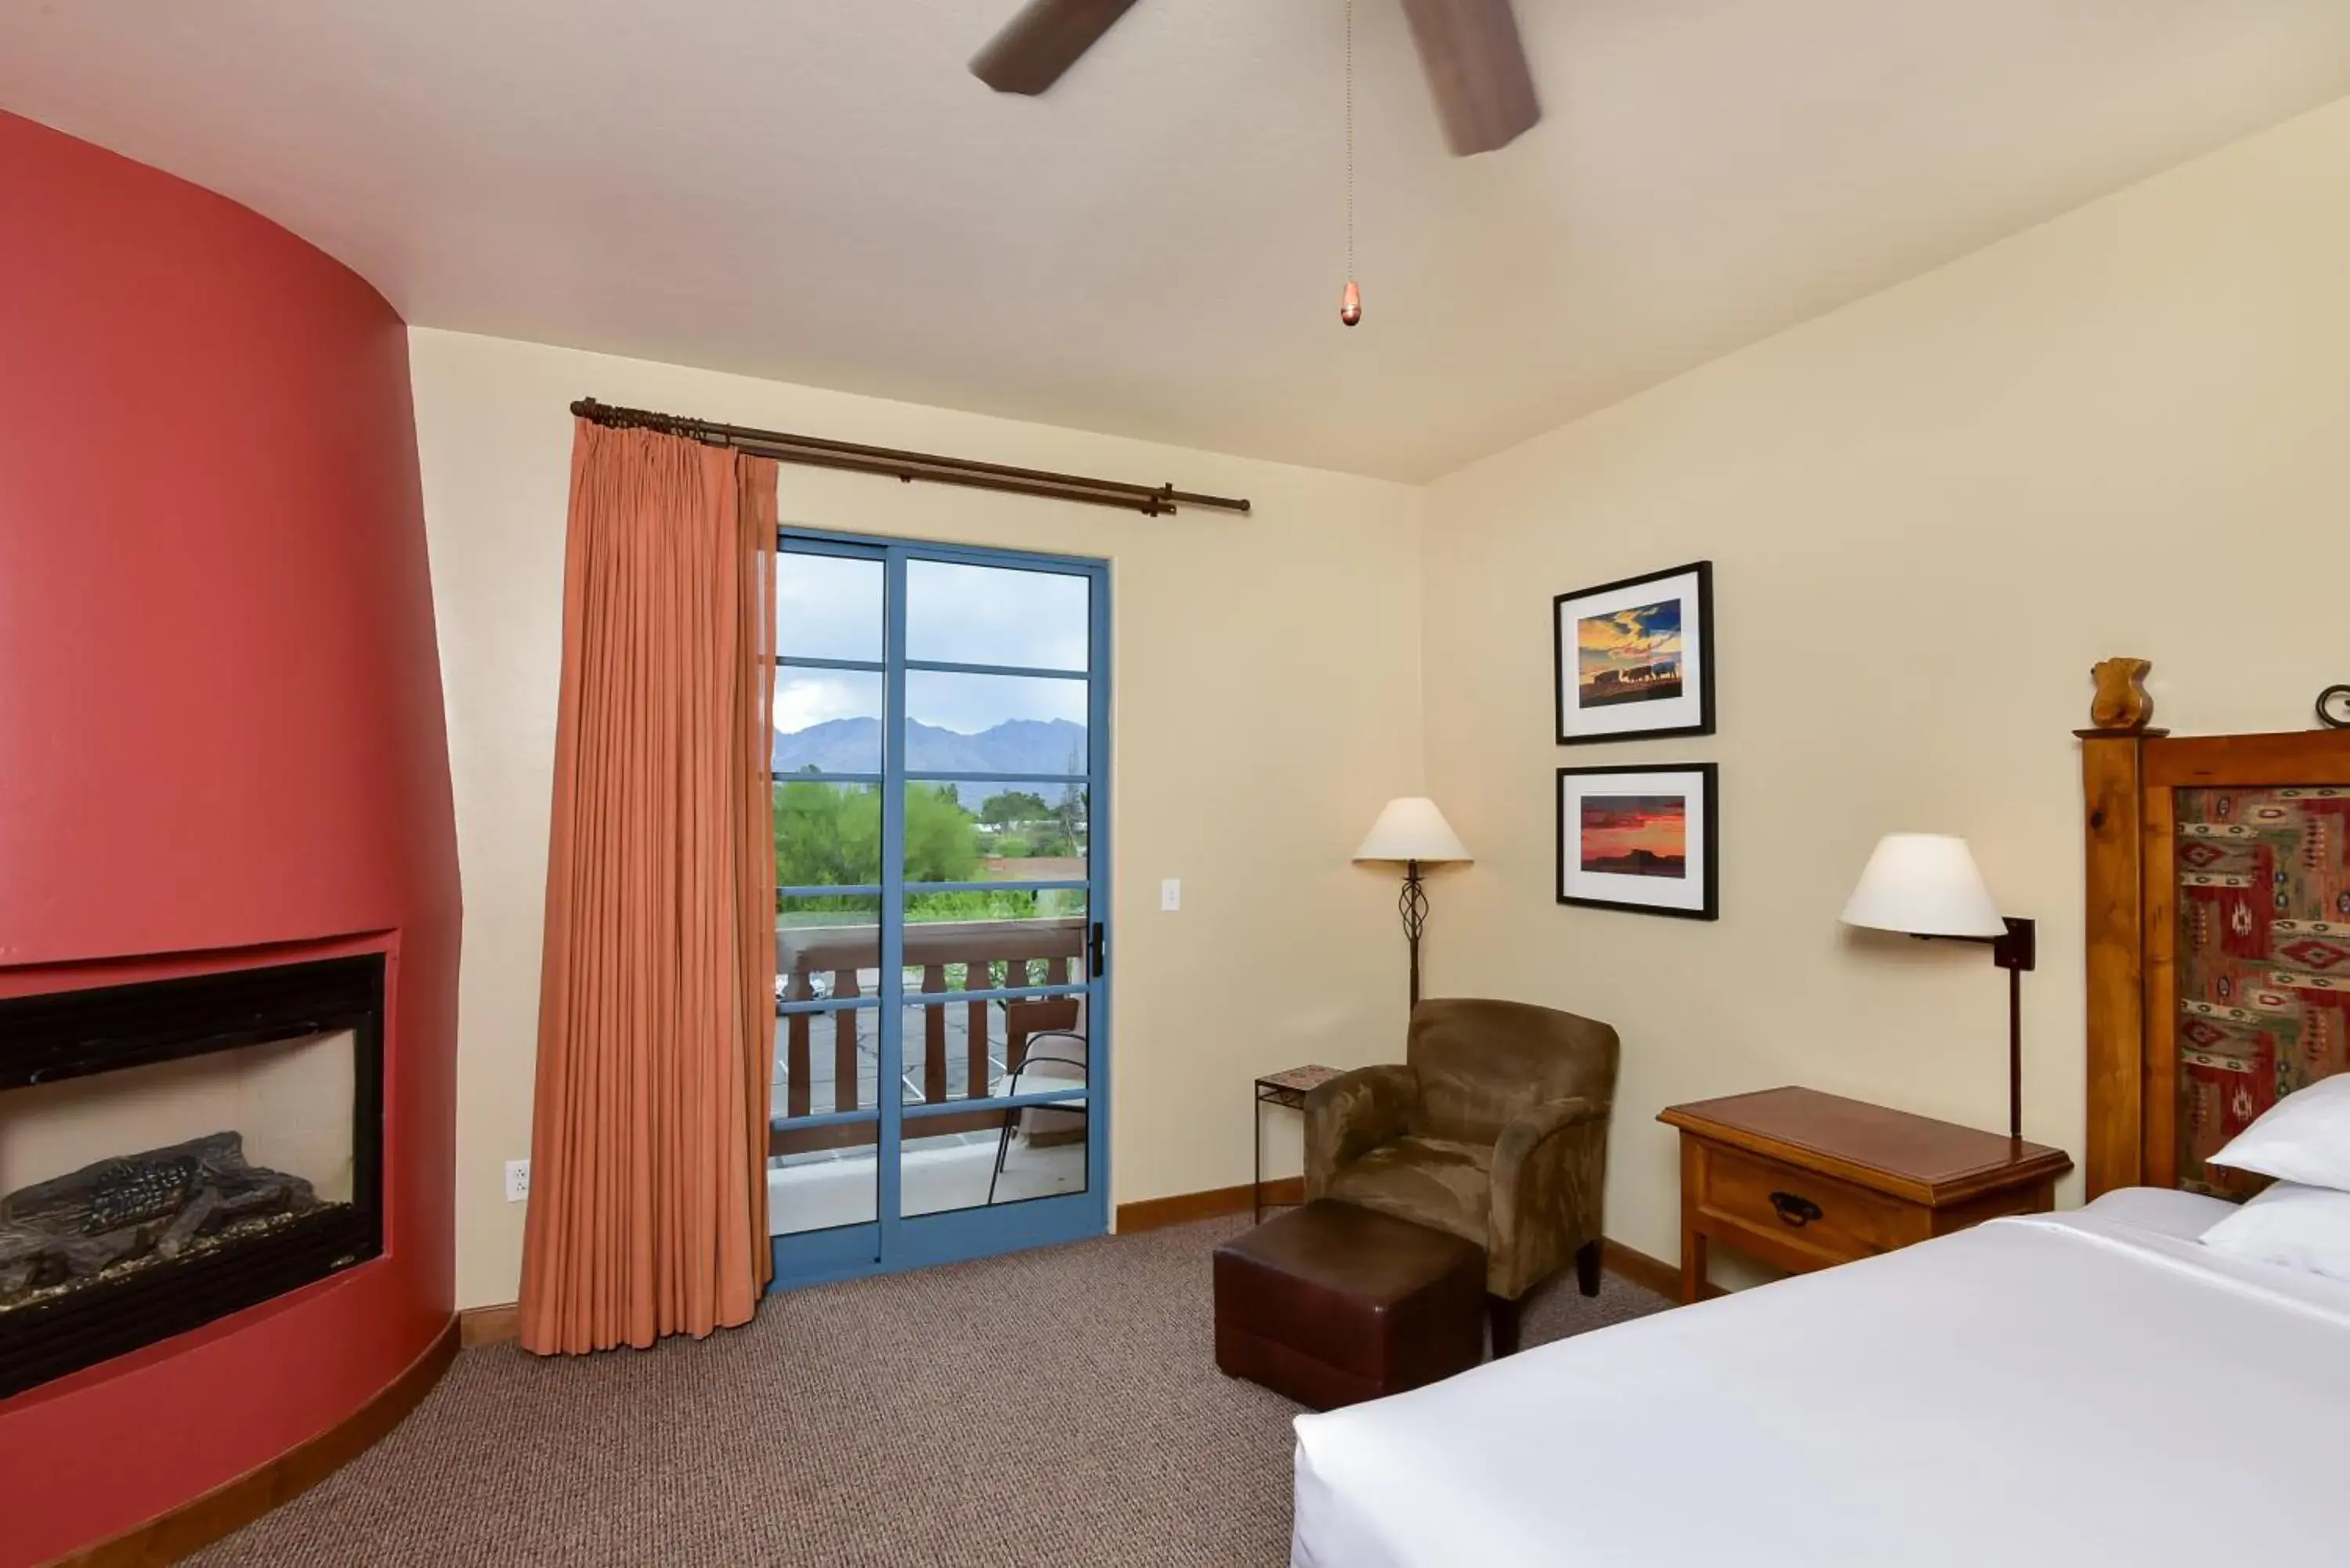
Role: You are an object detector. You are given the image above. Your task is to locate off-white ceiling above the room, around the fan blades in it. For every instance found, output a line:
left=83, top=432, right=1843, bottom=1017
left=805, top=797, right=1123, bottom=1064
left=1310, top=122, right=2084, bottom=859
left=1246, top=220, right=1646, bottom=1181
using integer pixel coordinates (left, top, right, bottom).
left=0, top=0, right=2350, bottom=479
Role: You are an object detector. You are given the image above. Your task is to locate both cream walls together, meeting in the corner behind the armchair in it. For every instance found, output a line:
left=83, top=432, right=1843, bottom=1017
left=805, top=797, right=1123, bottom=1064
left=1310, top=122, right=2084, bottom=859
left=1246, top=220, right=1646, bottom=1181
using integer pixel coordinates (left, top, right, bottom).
left=411, top=106, right=2350, bottom=1305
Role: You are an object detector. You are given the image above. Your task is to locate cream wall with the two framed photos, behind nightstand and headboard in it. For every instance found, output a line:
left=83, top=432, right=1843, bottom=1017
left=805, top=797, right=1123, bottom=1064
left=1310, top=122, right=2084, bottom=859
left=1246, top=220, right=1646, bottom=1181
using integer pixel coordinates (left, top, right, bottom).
left=1422, top=95, right=2350, bottom=1255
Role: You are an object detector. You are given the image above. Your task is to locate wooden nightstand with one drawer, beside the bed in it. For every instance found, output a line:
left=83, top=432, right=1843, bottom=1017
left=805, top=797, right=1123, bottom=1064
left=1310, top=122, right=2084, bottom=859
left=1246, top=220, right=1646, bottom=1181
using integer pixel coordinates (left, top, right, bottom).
left=1657, top=1089, right=2073, bottom=1302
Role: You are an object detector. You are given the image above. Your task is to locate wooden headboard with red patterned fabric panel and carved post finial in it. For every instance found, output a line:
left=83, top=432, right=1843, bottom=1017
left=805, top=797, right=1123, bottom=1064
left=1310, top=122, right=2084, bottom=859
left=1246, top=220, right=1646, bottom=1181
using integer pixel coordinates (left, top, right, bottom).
left=2077, top=660, right=2350, bottom=1197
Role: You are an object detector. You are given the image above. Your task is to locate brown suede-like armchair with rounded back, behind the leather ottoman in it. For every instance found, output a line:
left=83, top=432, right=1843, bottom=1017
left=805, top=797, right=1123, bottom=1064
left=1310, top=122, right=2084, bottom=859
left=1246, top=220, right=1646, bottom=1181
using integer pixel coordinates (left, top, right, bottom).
left=1307, top=999, right=1617, bottom=1354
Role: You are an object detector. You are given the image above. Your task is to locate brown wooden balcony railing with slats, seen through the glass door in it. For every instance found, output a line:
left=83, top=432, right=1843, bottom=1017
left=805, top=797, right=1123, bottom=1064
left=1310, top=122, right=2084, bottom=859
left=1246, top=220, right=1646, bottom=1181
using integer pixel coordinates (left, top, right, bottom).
left=776, top=917, right=1086, bottom=1152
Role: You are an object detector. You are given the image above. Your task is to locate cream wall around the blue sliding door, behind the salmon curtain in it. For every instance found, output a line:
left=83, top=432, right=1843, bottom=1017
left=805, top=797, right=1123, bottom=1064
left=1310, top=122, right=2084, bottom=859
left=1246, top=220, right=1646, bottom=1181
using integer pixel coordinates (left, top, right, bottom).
left=411, top=329, right=1422, bottom=1305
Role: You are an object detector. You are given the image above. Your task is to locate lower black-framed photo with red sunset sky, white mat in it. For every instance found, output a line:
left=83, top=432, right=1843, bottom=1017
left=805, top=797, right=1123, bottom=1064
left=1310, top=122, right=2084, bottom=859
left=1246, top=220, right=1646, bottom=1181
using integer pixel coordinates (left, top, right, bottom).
left=1558, top=761, right=1720, bottom=919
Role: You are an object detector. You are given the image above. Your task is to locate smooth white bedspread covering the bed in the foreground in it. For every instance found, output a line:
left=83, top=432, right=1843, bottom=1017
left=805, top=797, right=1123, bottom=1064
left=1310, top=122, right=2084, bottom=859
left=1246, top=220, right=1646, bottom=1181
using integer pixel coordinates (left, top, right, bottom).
left=1290, top=1192, right=2350, bottom=1568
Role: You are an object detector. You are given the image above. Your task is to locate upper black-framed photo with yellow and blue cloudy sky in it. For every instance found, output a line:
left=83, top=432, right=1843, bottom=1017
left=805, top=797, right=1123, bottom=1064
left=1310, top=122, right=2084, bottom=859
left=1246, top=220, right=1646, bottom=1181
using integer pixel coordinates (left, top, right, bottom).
left=1551, top=562, right=1713, bottom=745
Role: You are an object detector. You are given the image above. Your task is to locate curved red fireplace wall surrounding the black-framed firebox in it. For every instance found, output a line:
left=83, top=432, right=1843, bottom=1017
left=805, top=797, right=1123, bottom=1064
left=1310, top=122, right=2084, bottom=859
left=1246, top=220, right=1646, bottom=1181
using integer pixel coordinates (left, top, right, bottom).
left=0, top=115, right=458, bottom=1568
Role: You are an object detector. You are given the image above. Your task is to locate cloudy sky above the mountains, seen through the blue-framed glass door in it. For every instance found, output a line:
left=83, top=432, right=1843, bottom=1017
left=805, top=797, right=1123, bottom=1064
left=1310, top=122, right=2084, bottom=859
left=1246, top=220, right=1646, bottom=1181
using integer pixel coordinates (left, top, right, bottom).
left=776, top=555, right=1090, bottom=735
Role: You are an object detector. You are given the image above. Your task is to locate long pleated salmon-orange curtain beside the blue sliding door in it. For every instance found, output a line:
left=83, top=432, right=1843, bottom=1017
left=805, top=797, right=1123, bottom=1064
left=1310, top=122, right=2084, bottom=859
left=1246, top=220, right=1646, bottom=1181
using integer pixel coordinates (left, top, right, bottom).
left=522, top=421, right=776, bottom=1354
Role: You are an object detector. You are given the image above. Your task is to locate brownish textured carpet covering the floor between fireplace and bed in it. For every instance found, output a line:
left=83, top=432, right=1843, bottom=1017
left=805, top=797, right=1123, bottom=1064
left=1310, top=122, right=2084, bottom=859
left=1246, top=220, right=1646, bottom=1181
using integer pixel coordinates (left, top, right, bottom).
left=193, top=1220, right=1666, bottom=1568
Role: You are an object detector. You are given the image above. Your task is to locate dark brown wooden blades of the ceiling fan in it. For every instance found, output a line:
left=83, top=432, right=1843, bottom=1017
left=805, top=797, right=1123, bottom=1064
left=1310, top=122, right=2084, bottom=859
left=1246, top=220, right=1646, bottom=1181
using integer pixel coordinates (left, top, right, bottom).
left=971, top=0, right=1542, bottom=157
